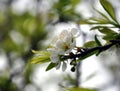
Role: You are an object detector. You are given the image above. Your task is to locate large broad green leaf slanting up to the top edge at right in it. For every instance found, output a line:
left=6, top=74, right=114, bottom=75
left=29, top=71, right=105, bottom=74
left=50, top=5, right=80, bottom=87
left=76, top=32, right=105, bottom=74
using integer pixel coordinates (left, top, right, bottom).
left=100, top=0, right=117, bottom=22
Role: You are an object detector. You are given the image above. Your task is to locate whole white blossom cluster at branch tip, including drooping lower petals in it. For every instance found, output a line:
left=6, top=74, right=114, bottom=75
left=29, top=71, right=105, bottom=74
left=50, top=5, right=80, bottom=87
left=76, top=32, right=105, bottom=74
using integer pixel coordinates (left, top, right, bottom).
left=47, top=28, right=80, bottom=71
